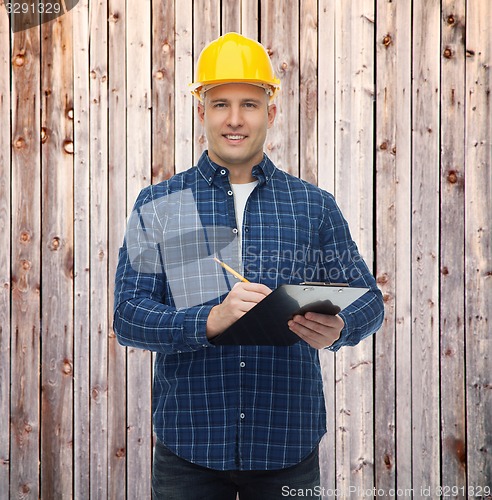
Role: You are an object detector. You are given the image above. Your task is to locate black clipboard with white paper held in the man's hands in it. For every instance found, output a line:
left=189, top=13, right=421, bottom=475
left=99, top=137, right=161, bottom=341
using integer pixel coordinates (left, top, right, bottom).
left=210, top=283, right=369, bottom=346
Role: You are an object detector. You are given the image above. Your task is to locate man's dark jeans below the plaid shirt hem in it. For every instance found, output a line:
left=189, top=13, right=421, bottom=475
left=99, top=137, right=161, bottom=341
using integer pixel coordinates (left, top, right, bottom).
left=152, top=441, right=319, bottom=500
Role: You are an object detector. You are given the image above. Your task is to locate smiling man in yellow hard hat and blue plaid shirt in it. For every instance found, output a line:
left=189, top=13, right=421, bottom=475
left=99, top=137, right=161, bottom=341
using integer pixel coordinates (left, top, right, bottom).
left=114, top=33, right=383, bottom=500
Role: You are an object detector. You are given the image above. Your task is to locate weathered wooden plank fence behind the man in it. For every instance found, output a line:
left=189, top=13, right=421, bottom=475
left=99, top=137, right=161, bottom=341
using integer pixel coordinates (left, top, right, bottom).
left=0, top=0, right=492, bottom=499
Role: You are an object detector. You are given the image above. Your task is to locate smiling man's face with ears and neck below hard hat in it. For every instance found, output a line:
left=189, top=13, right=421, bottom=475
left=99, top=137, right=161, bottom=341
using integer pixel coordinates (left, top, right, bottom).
left=198, top=83, right=276, bottom=182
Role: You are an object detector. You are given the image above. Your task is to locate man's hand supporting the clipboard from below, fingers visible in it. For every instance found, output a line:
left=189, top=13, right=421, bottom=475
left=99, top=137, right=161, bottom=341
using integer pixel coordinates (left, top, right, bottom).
left=289, top=312, right=345, bottom=349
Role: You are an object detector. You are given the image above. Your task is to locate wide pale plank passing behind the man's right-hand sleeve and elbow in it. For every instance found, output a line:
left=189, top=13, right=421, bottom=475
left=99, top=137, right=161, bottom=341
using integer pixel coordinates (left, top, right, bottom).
left=335, top=1, right=374, bottom=492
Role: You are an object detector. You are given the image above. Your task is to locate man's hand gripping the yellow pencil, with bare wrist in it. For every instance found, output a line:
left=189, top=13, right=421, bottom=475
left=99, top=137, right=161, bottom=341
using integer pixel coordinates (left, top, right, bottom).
left=207, top=282, right=272, bottom=339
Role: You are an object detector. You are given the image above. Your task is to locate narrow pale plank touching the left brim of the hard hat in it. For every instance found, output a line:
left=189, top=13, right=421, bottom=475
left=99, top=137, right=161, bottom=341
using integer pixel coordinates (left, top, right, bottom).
left=174, top=0, right=195, bottom=172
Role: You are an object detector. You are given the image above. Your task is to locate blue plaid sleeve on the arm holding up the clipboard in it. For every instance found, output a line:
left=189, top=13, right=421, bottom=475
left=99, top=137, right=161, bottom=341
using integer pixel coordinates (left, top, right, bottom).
left=320, top=193, right=384, bottom=351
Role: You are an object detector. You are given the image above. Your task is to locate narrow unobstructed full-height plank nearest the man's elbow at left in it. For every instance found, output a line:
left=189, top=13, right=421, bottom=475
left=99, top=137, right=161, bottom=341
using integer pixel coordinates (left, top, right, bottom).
left=89, top=0, right=109, bottom=498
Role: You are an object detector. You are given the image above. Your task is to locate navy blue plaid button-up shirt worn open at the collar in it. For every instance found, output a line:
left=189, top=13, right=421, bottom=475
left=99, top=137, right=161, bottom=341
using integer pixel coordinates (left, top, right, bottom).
left=114, top=152, right=383, bottom=470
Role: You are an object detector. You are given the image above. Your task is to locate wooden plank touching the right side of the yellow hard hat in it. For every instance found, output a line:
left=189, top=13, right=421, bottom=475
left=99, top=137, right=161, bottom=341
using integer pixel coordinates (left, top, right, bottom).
left=260, top=0, right=299, bottom=176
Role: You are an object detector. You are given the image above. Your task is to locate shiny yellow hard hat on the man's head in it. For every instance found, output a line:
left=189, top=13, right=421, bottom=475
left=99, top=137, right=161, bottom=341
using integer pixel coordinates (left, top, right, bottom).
left=190, top=33, right=280, bottom=101
